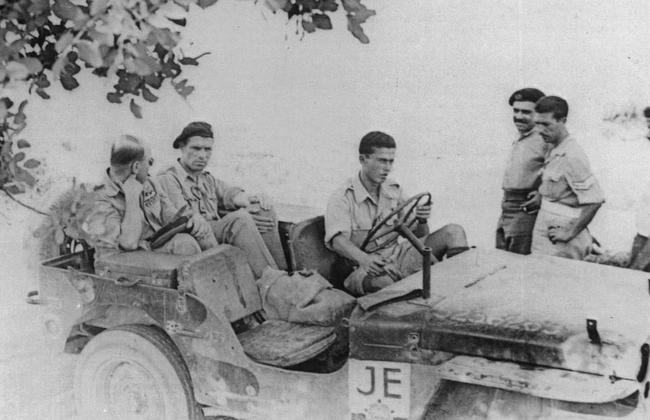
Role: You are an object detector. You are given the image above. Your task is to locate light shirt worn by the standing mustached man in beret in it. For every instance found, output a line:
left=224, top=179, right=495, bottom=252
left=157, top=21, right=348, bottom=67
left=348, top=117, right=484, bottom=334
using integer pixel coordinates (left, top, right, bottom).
left=502, top=130, right=550, bottom=191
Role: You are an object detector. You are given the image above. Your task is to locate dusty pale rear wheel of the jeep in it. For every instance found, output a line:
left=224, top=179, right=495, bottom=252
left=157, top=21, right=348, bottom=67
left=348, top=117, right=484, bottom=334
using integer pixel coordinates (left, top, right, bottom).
left=74, top=325, right=203, bottom=420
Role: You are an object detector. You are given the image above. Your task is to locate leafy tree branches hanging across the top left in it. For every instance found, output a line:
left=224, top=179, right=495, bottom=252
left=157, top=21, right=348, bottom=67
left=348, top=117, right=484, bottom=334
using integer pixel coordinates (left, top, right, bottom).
left=0, top=0, right=375, bottom=186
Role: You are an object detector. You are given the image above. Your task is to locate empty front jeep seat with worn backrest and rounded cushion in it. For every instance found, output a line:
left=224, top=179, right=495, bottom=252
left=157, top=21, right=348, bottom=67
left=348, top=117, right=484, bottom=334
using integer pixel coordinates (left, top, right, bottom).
left=179, top=245, right=336, bottom=367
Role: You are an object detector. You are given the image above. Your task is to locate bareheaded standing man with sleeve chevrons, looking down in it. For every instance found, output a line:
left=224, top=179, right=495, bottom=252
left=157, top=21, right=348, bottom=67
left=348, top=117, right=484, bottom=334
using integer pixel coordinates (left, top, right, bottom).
left=532, top=96, right=605, bottom=260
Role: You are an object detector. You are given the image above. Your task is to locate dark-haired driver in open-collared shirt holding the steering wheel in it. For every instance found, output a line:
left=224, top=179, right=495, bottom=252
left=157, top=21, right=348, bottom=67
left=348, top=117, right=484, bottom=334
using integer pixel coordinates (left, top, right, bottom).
left=325, top=131, right=468, bottom=296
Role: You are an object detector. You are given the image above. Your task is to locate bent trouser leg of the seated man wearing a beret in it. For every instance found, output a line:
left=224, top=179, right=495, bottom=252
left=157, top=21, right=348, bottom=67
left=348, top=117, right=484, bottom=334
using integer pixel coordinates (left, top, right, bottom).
left=210, top=209, right=278, bottom=278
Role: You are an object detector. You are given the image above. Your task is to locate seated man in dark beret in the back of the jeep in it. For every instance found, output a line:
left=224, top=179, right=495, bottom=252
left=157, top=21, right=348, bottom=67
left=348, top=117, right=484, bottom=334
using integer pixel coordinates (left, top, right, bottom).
left=157, top=121, right=284, bottom=277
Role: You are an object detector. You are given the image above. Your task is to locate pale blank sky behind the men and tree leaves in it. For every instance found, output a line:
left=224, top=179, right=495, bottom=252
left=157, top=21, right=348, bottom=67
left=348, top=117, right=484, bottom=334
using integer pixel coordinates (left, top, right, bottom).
left=5, top=0, right=650, bottom=249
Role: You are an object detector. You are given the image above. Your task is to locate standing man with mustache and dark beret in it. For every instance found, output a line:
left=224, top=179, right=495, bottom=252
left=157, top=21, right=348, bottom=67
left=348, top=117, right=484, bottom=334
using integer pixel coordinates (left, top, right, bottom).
left=496, top=88, right=549, bottom=254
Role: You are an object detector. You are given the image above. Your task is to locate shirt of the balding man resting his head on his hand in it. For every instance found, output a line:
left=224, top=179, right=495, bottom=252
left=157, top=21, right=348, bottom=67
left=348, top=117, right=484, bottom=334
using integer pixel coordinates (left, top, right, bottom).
left=82, top=170, right=178, bottom=249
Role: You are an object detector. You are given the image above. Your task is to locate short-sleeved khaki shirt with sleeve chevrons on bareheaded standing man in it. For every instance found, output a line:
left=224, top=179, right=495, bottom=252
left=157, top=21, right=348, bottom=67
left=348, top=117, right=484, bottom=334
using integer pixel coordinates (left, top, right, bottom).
left=539, top=137, right=605, bottom=207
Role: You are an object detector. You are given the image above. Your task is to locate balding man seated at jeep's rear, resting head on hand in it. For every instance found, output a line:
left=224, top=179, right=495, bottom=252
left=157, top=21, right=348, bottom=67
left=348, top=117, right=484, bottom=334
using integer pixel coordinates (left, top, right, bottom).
left=82, top=135, right=216, bottom=258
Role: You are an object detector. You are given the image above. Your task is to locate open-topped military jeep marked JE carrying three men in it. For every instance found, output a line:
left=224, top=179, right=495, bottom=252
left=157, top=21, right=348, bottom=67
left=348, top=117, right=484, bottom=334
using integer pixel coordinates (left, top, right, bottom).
left=31, top=202, right=650, bottom=420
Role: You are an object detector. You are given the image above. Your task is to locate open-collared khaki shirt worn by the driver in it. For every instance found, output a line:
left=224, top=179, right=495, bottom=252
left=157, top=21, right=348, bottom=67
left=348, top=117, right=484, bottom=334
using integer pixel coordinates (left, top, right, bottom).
left=325, top=174, right=405, bottom=248
